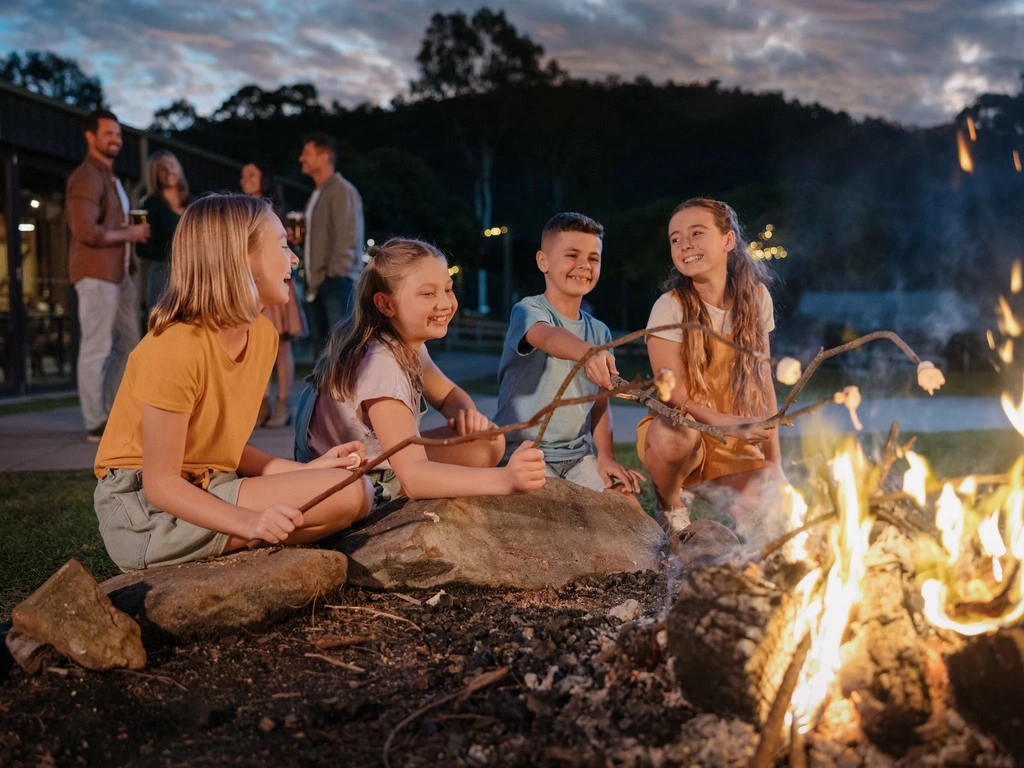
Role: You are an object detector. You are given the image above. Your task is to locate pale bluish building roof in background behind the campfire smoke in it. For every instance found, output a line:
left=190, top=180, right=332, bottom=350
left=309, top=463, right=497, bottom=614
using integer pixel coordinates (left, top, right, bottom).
left=797, top=291, right=986, bottom=338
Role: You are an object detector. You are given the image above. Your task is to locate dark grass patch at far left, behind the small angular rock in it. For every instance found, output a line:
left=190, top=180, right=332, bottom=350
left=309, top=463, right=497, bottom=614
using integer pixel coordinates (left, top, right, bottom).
left=0, top=470, right=119, bottom=622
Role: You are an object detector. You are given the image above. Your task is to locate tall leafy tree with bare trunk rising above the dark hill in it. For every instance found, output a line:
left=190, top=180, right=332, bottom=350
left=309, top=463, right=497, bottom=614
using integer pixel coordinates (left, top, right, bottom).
left=412, top=8, right=565, bottom=228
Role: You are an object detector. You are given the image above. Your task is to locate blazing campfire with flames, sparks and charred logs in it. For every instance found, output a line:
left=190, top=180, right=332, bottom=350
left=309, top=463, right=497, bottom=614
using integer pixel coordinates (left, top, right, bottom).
left=666, top=305, right=1024, bottom=766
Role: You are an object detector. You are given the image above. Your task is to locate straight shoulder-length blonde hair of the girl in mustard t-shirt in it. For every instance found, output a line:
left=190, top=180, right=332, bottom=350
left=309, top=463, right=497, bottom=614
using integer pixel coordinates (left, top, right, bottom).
left=148, top=194, right=273, bottom=335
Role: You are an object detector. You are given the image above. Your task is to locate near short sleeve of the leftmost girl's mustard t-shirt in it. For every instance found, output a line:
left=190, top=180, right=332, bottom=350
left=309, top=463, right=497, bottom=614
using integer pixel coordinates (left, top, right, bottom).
left=133, top=329, right=206, bottom=414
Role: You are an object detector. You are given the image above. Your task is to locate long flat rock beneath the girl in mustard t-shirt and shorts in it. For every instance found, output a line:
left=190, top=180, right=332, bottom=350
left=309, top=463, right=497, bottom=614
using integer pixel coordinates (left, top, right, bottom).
left=102, top=547, right=348, bottom=641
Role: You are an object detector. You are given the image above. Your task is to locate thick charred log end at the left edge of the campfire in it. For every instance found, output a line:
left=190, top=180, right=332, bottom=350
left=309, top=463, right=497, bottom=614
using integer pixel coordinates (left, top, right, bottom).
left=667, top=565, right=798, bottom=726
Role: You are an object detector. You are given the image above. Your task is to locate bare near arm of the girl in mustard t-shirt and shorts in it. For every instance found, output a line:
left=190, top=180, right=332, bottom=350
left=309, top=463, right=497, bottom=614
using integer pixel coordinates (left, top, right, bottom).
left=142, top=404, right=302, bottom=544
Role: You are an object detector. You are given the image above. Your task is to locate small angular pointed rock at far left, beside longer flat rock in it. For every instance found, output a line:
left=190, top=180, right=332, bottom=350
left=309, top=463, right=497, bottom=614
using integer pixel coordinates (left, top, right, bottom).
left=7, top=560, right=145, bottom=670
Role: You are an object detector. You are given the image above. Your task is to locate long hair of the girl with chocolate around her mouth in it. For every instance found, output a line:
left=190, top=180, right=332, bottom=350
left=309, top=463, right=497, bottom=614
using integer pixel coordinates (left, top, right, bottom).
left=311, top=238, right=447, bottom=400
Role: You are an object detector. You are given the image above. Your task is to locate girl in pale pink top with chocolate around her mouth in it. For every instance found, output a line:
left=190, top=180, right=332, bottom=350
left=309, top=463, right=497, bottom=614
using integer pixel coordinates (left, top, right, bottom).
left=296, top=239, right=545, bottom=505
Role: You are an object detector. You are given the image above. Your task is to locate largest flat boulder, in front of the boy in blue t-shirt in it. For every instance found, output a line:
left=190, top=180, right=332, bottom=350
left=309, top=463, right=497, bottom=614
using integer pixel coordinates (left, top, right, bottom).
left=334, top=479, right=665, bottom=589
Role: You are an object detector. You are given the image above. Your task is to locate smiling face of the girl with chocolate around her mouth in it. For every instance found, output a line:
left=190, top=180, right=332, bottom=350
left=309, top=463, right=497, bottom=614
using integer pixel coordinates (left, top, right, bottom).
left=374, top=256, right=459, bottom=345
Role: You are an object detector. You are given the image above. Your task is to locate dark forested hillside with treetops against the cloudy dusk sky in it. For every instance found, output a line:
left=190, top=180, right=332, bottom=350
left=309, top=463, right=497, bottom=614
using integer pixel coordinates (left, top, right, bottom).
left=0, top=8, right=1024, bottom=328
